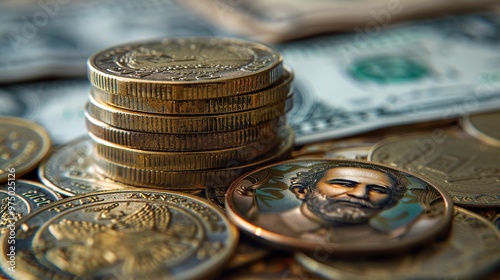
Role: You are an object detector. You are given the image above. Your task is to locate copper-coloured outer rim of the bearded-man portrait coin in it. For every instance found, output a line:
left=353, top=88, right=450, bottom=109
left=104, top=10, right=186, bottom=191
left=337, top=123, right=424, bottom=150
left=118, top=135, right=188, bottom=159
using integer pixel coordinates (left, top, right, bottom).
left=225, top=159, right=453, bottom=257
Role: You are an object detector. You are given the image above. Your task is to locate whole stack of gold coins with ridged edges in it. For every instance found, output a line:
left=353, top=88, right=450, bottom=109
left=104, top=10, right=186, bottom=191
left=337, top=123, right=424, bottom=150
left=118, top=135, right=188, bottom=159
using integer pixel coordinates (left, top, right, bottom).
left=85, top=37, right=293, bottom=189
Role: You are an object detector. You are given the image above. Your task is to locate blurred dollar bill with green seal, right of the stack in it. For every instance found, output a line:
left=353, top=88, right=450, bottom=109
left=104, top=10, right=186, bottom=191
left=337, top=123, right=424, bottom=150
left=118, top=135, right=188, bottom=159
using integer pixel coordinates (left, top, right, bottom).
left=286, top=15, right=500, bottom=144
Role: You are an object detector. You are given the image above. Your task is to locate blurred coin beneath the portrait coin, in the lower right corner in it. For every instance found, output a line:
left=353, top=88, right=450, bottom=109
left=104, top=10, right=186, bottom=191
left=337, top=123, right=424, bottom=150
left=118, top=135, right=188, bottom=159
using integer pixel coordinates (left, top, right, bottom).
left=296, top=207, right=500, bottom=280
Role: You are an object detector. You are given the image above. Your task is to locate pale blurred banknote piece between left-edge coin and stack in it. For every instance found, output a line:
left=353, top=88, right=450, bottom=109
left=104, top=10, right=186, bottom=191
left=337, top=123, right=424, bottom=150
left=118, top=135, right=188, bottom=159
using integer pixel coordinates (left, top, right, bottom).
left=0, top=79, right=90, bottom=144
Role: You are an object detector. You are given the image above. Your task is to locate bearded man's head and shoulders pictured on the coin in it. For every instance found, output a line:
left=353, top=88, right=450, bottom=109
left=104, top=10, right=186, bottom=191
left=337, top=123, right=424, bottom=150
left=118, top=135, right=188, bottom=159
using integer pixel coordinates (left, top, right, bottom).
left=250, top=164, right=418, bottom=242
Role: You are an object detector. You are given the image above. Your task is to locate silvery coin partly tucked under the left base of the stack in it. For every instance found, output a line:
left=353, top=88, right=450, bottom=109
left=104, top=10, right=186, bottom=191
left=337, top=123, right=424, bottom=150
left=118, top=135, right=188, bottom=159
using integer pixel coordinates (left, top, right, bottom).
left=38, top=135, right=134, bottom=196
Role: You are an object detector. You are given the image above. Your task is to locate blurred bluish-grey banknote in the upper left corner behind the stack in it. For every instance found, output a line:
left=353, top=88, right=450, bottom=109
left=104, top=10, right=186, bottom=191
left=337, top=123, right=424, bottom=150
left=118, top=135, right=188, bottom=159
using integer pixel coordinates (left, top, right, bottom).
left=0, top=0, right=223, bottom=83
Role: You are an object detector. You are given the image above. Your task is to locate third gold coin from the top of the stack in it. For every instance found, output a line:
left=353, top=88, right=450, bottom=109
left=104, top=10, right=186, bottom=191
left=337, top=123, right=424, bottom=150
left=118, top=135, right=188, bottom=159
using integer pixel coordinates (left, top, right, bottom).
left=85, top=90, right=293, bottom=134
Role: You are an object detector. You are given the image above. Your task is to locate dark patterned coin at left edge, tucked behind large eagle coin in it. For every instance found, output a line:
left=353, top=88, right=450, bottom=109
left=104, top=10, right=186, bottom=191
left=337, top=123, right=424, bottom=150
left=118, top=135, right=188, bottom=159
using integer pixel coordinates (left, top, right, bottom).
left=0, top=180, right=62, bottom=235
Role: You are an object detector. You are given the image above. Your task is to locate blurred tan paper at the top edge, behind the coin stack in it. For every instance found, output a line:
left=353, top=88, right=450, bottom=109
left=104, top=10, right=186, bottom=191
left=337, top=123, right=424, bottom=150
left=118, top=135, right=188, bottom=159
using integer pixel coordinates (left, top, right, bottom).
left=178, top=0, right=497, bottom=43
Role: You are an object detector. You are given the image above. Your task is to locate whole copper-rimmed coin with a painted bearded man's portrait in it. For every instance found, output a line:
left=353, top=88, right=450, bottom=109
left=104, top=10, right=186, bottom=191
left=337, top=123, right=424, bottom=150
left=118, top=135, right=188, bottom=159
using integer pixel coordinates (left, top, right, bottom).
left=226, top=160, right=453, bottom=257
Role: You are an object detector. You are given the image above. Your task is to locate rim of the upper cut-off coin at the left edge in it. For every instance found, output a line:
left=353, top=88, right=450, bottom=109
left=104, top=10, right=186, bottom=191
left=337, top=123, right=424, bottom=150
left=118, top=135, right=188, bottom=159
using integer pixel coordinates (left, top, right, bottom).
left=0, top=116, right=52, bottom=183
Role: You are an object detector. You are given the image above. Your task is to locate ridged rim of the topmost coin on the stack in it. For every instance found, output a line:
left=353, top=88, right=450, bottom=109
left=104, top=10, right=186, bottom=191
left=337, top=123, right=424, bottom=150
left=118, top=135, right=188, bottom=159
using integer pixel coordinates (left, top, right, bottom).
left=87, top=36, right=283, bottom=100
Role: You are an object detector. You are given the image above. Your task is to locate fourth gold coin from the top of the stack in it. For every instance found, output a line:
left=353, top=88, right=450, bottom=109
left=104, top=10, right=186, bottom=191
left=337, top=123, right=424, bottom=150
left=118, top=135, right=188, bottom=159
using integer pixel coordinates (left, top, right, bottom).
left=84, top=112, right=286, bottom=152
